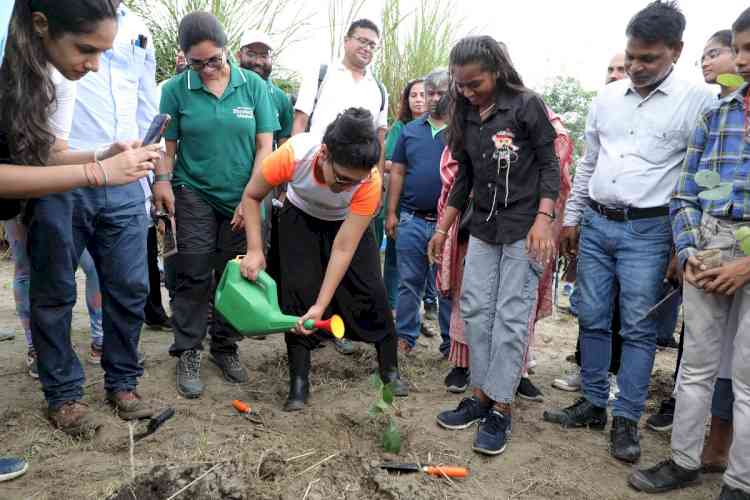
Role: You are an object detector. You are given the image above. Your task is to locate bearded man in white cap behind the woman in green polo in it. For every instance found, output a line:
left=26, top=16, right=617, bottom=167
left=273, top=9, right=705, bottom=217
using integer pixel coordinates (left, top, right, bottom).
left=237, top=30, right=294, bottom=149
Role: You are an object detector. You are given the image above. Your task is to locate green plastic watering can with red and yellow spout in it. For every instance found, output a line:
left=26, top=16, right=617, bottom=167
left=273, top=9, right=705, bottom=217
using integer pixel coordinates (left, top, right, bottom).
left=214, top=257, right=345, bottom=339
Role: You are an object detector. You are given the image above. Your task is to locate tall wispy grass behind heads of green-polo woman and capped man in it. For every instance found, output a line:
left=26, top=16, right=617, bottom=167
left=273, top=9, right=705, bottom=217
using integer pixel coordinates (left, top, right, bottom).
left=125, top=0, right=312, bottom=81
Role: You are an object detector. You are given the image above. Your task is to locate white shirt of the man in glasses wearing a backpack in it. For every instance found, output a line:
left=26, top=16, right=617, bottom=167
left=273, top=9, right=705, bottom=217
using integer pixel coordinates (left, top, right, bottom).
left=294, top=62, right=388, bottom=141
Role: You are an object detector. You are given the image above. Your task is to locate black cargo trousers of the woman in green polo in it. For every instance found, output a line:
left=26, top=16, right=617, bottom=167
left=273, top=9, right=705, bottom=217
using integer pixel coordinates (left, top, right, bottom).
left=169, top=186, right=246, bottom=356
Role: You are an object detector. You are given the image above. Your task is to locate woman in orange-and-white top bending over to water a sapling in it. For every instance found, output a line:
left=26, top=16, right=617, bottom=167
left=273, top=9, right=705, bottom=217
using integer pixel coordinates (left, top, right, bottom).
left=241, top=108, right=408, bottom=411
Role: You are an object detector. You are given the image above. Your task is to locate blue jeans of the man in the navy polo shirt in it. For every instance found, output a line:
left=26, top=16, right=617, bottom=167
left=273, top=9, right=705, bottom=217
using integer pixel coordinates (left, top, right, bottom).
left=396, top=210, right=451, bottom=355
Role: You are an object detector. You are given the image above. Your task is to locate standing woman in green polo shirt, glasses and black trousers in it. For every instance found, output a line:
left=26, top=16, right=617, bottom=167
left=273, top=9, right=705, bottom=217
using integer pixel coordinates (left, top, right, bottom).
left=154, top=12, right=279, bottom=398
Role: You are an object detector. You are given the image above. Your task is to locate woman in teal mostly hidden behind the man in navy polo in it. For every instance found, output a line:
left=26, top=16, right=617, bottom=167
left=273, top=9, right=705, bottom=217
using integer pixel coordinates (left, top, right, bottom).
left=384, top=78, right=426, bottom=311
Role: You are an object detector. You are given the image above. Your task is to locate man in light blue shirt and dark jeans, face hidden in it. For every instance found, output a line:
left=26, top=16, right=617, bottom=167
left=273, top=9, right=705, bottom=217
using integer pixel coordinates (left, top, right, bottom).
left=29, top=0, right=158, bottom=435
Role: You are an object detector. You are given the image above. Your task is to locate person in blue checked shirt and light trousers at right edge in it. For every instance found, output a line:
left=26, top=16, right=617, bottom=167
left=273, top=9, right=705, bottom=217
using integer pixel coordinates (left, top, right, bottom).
left=630, top=9, right=750, bottom=500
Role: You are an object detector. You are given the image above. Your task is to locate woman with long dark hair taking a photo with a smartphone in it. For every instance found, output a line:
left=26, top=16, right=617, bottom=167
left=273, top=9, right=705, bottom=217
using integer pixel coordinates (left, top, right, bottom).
left=0, top=0, right=159, bottom=481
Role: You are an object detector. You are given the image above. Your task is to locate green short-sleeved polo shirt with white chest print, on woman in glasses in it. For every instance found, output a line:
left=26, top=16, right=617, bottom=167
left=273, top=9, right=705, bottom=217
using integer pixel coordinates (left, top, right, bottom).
left=160, top=64, right=279, bottom=215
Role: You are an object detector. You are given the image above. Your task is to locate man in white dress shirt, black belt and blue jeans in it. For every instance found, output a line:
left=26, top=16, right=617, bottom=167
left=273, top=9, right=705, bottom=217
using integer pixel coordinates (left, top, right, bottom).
left=544, top=0, right=713, bottom=462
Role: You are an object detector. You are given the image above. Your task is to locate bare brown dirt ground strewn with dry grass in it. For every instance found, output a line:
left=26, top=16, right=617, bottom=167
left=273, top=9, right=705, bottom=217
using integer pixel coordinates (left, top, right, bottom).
left=0, top=262, right=720, bottom=500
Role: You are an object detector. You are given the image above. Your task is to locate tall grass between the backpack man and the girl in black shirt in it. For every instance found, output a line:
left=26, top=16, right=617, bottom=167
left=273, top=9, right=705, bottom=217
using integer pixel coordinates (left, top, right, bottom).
left=375, top=0, right=463, bottom=123
